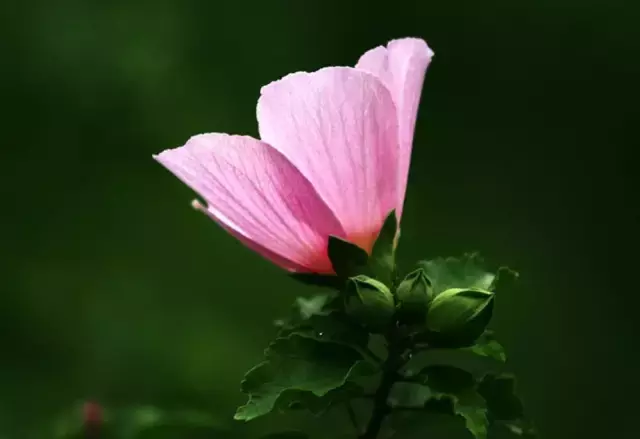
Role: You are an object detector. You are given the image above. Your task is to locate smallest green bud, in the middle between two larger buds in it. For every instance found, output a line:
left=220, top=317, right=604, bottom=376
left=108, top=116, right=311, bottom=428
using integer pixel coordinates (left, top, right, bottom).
left=396, top=268, right=433, bottom=324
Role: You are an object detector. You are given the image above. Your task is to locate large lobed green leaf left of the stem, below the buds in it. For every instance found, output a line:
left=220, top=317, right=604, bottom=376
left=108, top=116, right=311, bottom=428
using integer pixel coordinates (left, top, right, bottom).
left=234, top=333, right=362, bottom=421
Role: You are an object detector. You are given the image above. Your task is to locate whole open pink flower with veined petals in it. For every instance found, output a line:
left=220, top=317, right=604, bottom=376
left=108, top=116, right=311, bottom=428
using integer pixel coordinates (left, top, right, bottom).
left=154, top=38, right=433, bottom=273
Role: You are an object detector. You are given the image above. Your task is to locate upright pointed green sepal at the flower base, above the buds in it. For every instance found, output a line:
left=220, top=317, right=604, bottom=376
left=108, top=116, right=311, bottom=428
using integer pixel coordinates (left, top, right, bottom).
left=369, top=209, right=398, bottom=288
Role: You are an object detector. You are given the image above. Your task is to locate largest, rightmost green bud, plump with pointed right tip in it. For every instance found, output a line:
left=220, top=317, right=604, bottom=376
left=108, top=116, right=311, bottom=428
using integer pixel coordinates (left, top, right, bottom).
left=427, top=288, right=494, bottom=348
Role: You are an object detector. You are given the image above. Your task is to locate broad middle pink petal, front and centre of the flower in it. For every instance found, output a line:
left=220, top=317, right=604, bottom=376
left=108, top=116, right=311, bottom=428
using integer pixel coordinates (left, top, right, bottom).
left=257, top=67, right=399, bottom=250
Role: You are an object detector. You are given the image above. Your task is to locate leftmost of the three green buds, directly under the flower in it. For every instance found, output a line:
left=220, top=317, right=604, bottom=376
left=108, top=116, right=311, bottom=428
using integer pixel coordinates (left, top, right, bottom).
left=345, top=275, right=395, bottom=333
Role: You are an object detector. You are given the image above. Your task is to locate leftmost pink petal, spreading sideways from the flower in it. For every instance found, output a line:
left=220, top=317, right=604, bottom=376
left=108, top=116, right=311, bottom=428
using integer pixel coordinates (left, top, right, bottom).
left=155, top=134, right=344, bottom=273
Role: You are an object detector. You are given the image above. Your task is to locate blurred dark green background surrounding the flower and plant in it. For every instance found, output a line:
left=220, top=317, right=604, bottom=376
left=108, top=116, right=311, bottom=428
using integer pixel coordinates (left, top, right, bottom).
left=0, top=0, right=640, bottom=439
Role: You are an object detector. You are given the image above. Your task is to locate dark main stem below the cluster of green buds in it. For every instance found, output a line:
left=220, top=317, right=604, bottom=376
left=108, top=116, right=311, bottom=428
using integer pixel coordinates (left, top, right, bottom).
left=359, top=330, right=405, bottom=439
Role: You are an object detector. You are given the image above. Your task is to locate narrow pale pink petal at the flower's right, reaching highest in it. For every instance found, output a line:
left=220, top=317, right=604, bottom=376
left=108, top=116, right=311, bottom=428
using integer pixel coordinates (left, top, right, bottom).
left=356, top=38, right=433, bottom=218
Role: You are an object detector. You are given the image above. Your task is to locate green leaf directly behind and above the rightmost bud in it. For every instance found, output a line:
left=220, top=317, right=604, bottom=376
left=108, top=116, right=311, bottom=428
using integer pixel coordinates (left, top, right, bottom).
left=418, top=253, right=496, bottom=295
